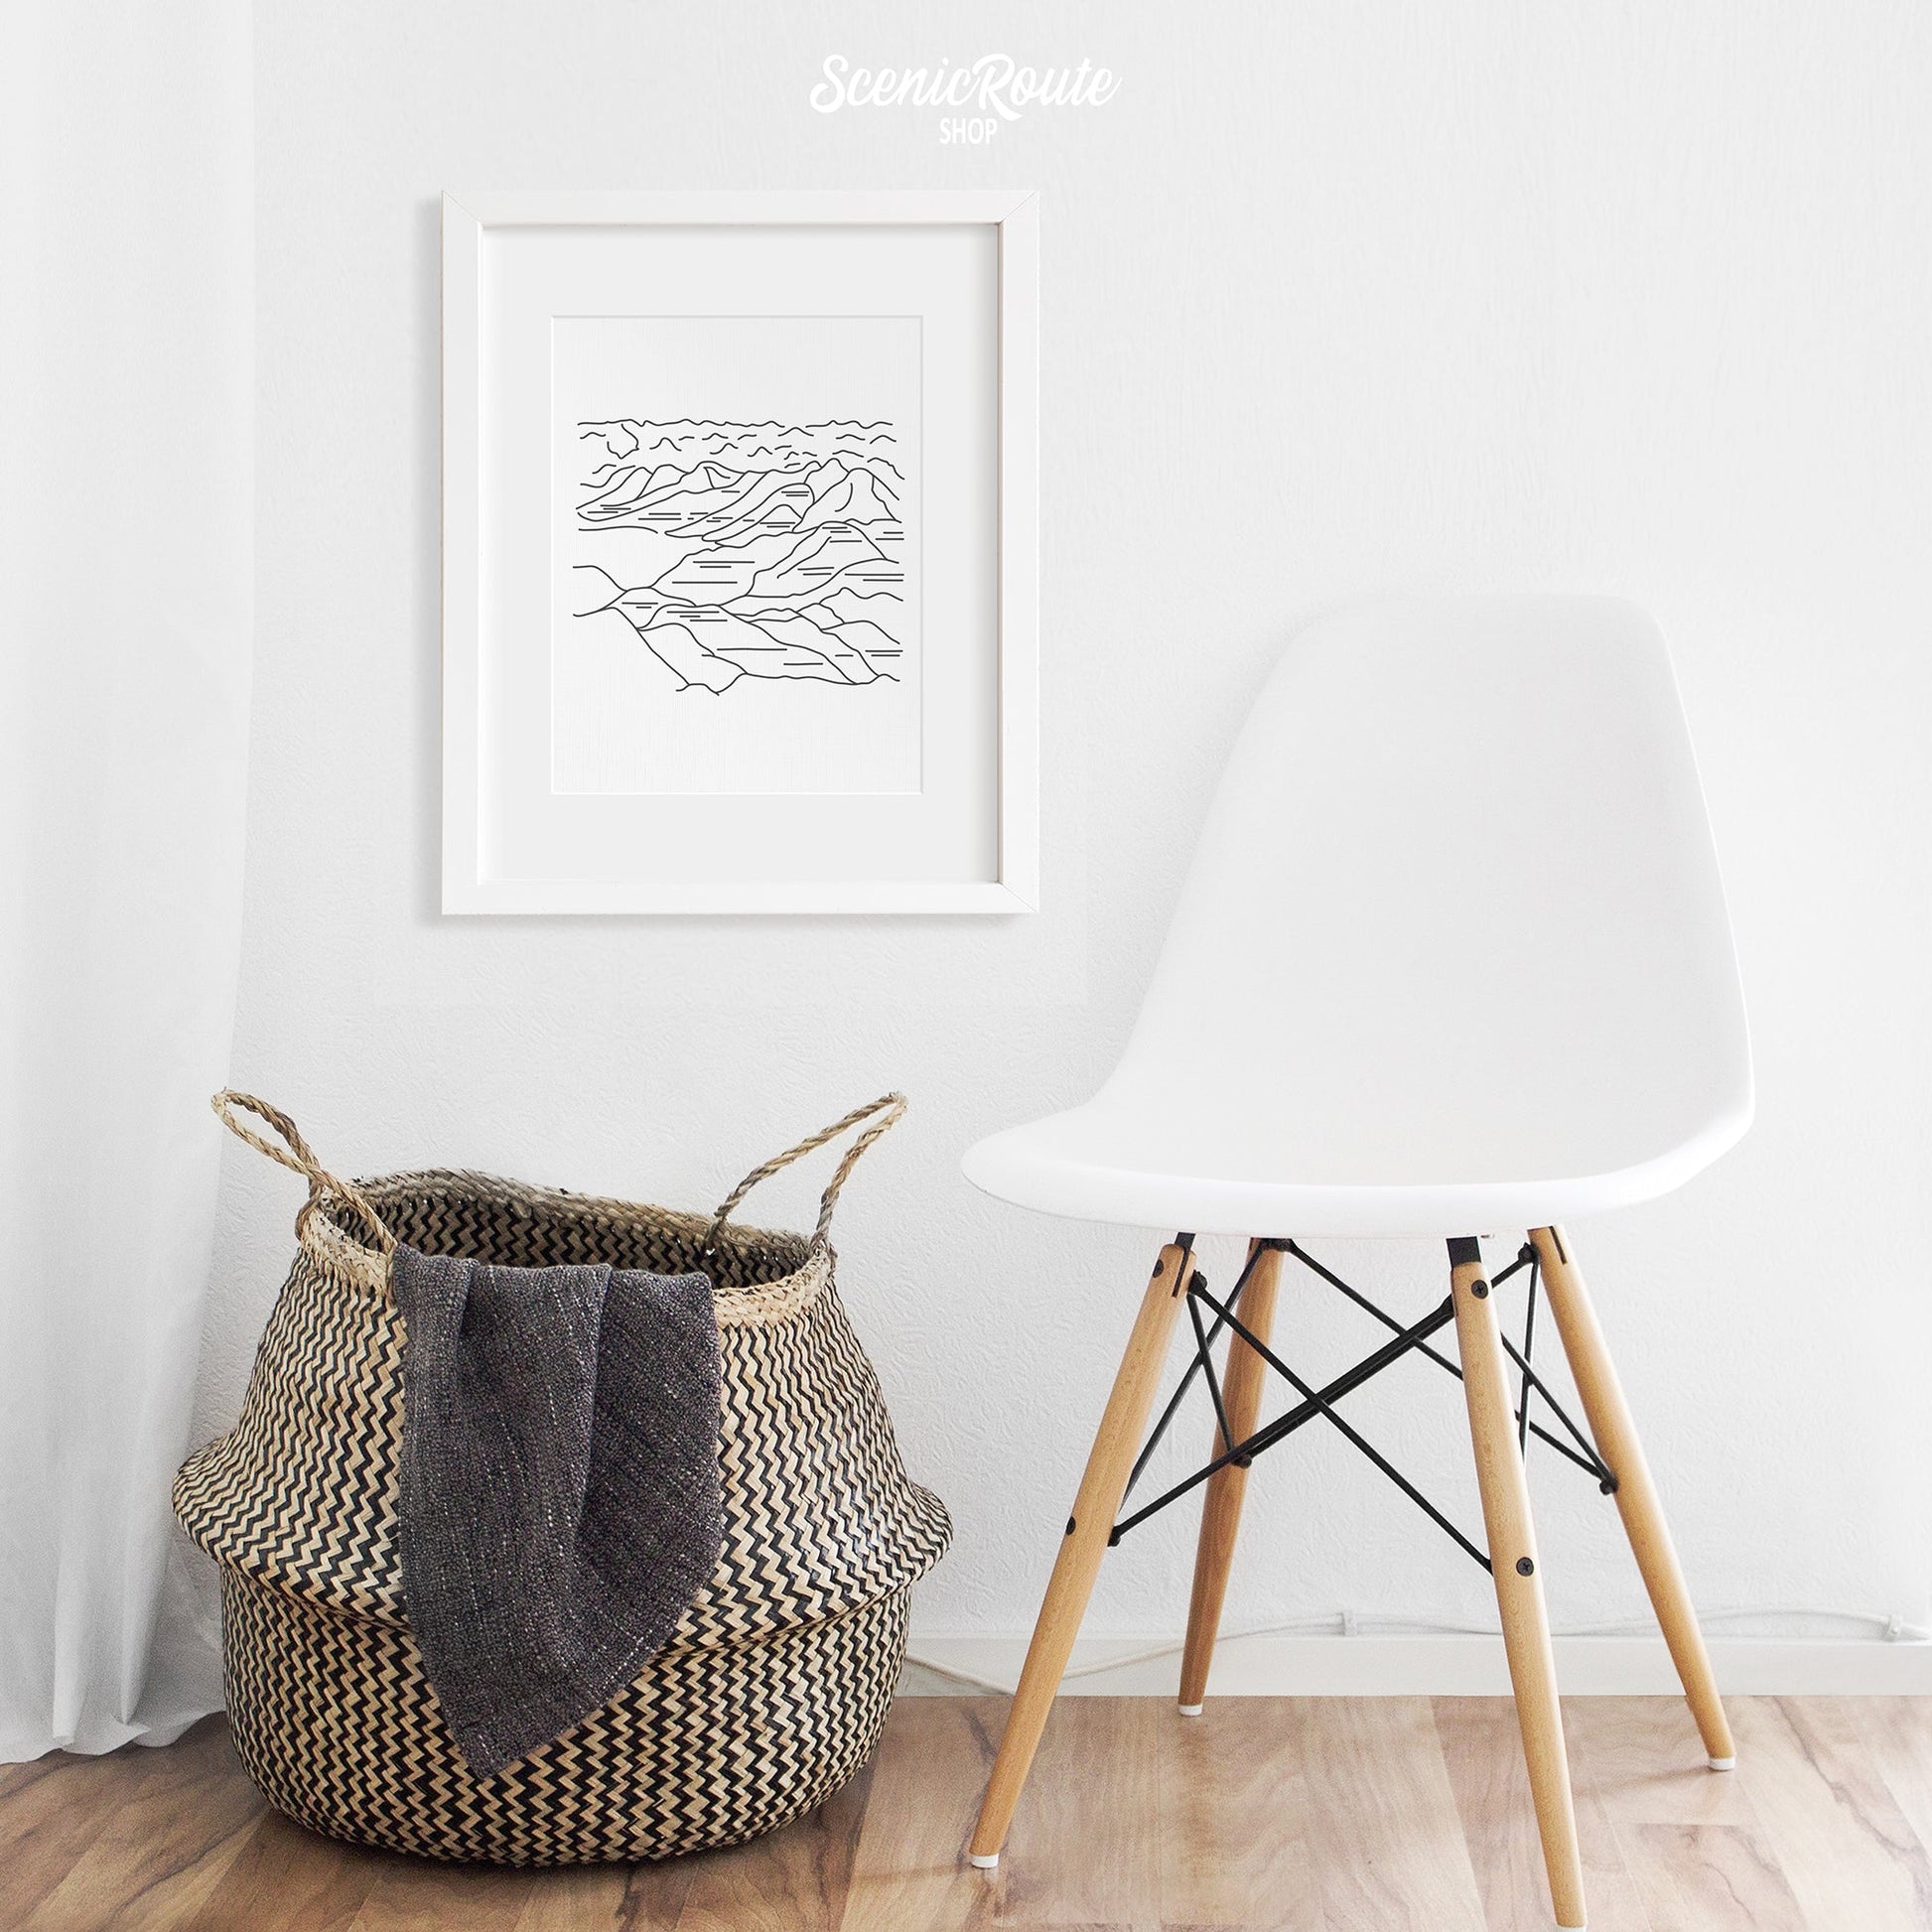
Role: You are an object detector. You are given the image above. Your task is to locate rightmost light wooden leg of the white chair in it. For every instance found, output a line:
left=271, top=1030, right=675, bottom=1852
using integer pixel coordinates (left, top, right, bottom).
left=1530, top=1227, right=1736, bottom=1771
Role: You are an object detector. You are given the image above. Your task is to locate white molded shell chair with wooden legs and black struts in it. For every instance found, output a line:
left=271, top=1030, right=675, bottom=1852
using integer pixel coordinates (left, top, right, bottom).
left=964, top=597, right=1752, bottom=1926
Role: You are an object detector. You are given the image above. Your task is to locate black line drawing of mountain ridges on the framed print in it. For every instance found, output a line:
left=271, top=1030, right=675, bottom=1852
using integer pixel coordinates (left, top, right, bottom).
left=570, top=415, right=912, bottom=698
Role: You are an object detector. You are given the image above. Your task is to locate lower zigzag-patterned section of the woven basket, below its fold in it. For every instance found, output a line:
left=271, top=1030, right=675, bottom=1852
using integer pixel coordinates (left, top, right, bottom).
left=222, top=1575, right=906, bottom=1864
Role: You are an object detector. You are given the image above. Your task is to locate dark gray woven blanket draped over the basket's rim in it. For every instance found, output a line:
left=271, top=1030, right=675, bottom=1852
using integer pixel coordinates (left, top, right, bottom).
left=394, top=1246, right=721, bottom=1773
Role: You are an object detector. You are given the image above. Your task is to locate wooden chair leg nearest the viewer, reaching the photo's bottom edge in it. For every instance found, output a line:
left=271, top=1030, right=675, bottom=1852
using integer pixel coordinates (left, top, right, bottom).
left=1449, top=1240, right=1585, bottom=1928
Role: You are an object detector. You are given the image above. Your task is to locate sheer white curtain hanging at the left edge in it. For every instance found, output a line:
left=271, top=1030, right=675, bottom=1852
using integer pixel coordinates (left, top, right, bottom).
left=0, top=0, right=253, bottom=1760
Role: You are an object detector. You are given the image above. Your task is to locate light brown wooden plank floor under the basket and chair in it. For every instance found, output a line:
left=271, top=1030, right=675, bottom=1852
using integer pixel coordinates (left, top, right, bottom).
left=0, top=1699, right=1932, bottom=1932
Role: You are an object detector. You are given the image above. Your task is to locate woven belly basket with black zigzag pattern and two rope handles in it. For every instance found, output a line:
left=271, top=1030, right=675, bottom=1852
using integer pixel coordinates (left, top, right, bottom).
left=174, top=1093, right=952, bottom=1864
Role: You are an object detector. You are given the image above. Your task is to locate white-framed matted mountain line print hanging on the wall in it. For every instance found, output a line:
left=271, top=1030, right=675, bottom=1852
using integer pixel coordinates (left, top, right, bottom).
left=443, top=192, right=1039, bottom=912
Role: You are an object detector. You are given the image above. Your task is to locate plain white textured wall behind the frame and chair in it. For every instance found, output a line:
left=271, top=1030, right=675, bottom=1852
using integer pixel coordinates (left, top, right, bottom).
left=203, top=0, right=1932, bottom=1677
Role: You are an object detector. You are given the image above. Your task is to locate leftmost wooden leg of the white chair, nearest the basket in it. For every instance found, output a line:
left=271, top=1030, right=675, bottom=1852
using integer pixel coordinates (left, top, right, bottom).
left=970, top=1244, right=1194, bottom=1864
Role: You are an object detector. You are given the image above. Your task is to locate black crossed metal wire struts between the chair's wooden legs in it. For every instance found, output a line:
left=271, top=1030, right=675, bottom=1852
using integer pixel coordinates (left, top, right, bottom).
left=1105, top=1234, right=1617, bottom=1569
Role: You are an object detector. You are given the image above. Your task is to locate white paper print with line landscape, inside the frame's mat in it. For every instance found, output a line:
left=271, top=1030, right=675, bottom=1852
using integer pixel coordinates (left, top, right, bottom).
left=547, top=315, right=931, bottom=798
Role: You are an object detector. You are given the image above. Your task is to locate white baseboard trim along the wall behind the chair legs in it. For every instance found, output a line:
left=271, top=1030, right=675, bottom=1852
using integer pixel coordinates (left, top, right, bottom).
left=900, top=1636, right=1932, bottom=1699
